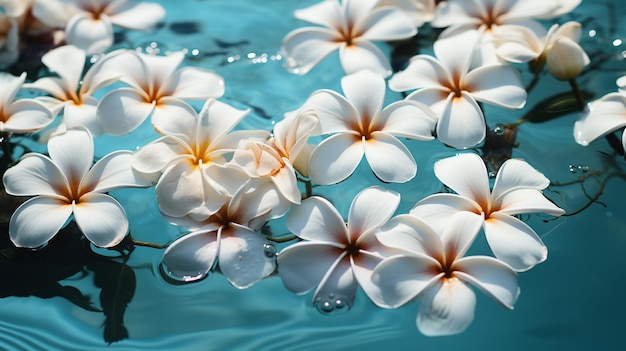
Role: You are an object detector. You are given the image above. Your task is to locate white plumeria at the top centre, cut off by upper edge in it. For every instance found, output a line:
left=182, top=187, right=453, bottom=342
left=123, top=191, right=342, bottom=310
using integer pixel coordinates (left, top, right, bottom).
left=282, top=0, right=417, bottom=77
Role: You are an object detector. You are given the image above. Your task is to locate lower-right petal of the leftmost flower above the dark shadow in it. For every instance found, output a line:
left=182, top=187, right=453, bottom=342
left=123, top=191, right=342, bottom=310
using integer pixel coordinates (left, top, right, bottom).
left=74, top=193, right=128, bottom=247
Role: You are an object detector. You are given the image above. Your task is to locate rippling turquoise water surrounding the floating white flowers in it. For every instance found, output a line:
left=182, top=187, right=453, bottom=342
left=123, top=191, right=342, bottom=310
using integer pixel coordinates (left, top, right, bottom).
left=0, top=0, right=626, bottom=350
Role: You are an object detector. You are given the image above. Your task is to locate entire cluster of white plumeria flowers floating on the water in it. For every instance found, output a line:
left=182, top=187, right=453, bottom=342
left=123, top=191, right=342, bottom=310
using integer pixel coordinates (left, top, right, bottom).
left=0, top=0, right=608, bottom=335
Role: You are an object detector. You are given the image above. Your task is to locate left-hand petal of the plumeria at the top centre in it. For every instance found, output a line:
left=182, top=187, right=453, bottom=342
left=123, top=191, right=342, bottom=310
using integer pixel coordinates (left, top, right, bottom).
left=281, top=27, right=342, bottom=74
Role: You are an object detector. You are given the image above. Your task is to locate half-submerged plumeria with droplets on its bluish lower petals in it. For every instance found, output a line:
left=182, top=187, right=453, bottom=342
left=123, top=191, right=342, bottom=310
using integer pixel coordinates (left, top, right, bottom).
left=163, top=182, right=282, bottom=289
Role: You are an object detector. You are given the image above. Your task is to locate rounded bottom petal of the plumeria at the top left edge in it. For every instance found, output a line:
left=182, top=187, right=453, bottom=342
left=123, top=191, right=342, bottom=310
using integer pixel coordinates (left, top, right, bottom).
left=65, top=13, right=113, bottom=55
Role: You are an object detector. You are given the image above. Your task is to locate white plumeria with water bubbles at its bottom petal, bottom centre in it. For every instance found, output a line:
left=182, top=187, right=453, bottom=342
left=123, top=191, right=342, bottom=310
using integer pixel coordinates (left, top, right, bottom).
left=278, top=187, right=400, bottom=309
